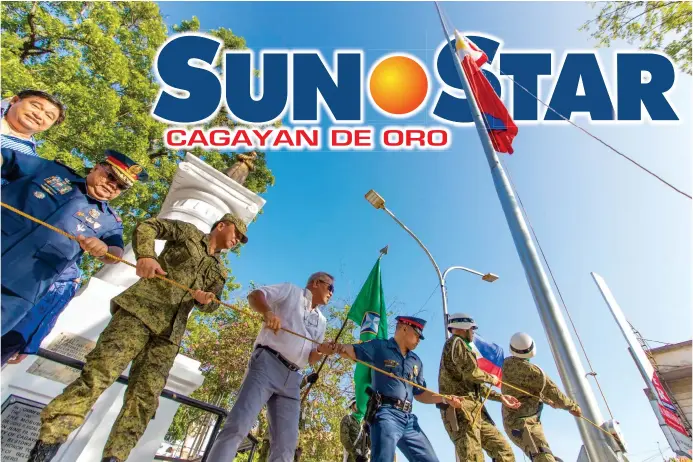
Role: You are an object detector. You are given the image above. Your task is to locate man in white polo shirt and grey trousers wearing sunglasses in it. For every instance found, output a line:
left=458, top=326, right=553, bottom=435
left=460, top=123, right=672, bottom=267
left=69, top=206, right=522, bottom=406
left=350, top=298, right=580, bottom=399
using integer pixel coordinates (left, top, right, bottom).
left=207, top=272, right=334, bottom=462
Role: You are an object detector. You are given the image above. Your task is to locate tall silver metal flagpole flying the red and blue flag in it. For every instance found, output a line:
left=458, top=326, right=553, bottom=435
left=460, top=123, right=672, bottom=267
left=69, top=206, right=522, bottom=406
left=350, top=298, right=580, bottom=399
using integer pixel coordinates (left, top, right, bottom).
left=435, top=2, right=619, bottom=462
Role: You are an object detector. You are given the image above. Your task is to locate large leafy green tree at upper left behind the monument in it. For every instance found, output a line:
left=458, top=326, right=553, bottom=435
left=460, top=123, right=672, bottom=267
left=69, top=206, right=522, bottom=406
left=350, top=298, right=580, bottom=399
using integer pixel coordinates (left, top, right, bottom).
left=0, top=2, right=274, bottom=282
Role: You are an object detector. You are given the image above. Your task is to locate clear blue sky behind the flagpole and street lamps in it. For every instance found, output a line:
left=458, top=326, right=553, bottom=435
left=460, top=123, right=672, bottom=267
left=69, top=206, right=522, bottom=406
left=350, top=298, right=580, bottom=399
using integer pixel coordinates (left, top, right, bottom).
left=161, top=2, right=693, bottom=461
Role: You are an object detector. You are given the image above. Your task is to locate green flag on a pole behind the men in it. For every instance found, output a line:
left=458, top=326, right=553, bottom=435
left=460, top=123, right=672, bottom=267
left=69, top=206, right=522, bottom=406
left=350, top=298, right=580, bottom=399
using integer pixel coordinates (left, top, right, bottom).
left=348, top=258, right=388, bottom=422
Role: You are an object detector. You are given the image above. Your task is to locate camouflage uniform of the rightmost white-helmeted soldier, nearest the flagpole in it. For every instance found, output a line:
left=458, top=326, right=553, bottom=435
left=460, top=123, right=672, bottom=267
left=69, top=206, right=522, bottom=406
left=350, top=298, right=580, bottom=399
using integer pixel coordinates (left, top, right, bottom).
left=502, top=356, right=579, bottom=462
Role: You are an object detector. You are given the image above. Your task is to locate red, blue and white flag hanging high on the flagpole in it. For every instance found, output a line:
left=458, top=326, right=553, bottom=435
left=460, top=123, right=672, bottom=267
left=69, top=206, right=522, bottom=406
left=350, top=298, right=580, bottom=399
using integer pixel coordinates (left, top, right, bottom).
left=455, top=30, right=517, bottom=154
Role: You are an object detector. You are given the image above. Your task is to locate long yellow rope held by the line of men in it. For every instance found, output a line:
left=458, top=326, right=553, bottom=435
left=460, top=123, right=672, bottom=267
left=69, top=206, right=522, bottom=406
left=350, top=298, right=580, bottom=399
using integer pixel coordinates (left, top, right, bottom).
left=0, top=202, right=615, bottom=439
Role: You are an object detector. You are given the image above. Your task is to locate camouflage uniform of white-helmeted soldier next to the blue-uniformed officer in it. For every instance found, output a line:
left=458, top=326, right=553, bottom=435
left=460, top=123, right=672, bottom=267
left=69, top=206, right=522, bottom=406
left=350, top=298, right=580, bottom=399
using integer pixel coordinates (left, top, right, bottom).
left=438, top=335, right=515, bottom=462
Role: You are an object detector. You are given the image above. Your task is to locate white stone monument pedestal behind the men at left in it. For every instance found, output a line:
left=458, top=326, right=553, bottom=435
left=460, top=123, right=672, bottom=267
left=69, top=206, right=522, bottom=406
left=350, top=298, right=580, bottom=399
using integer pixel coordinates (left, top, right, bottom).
left=1, top=154, right=265, bottom=462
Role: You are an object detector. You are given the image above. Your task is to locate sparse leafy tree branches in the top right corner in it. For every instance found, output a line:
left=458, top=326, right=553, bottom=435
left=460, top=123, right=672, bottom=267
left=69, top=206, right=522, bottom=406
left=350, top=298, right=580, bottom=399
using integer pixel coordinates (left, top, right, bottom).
left=580, top=1, right=692, bottom=74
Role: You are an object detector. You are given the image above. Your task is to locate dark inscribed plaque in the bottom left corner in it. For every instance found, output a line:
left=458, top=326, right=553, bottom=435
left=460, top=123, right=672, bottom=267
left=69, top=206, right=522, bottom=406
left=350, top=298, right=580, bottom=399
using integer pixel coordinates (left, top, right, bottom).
left=0, top=395, right=45, bottom=462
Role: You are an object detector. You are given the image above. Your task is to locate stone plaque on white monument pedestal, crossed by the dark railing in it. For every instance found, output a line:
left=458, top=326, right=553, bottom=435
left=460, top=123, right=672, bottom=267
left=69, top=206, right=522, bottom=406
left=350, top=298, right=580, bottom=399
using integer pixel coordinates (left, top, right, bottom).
left=27, top=332, right=96, bottom=385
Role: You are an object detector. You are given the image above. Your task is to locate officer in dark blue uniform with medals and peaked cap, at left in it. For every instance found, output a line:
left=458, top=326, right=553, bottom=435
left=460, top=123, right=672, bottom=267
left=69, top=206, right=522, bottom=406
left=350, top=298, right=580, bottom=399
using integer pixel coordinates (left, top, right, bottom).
left=0, top=148, right=147, bottom=335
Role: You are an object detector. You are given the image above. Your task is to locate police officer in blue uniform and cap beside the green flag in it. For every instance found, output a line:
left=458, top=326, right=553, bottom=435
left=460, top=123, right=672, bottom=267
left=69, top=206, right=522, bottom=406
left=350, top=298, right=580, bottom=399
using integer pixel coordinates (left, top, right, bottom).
left=320, top=316, right=461, bottom=462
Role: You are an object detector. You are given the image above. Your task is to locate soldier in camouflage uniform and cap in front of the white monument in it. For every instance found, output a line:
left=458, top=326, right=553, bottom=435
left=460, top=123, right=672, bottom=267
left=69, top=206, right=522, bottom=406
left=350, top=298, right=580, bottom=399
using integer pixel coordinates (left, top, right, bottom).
left=29, top=213, right=248, bottom=462
